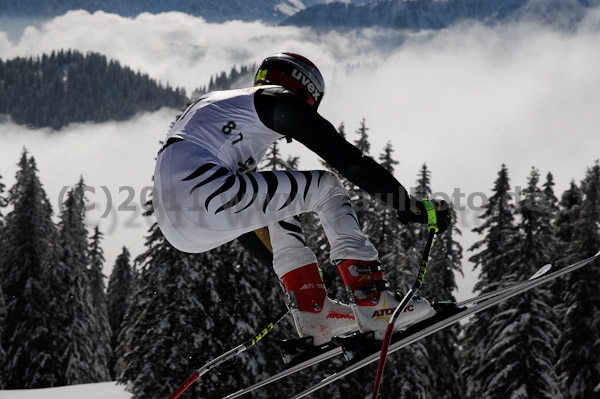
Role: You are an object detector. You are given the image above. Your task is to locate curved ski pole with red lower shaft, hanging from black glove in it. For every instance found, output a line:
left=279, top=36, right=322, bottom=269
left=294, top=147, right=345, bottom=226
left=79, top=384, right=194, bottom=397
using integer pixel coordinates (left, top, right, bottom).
left=373, top=225, right=437, bottom=399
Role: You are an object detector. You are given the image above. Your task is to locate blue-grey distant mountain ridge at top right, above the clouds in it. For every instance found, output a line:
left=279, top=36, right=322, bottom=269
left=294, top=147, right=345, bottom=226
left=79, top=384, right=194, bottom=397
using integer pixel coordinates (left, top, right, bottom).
left=280, top=0, right=600, bottom=31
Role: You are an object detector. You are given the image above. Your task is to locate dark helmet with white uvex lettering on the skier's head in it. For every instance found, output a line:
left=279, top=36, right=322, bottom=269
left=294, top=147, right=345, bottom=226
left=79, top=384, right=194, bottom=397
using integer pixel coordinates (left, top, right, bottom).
left=254, top=53, right=325, bottom=110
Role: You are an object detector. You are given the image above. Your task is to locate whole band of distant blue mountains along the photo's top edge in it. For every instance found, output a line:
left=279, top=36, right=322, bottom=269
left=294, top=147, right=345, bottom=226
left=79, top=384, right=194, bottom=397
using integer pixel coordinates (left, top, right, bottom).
left=0, top=0, right=600, bottom=31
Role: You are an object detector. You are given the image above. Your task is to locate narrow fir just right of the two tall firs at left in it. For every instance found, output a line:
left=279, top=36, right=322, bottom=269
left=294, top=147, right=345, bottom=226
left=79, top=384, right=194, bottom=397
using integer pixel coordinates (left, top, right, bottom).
left=88, top=226, right=113, bottom=381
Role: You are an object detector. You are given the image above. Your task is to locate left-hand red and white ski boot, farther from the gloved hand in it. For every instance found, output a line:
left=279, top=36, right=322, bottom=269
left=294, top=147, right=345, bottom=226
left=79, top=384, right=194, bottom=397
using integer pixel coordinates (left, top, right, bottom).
left=281, top=263, right=358, bottom=346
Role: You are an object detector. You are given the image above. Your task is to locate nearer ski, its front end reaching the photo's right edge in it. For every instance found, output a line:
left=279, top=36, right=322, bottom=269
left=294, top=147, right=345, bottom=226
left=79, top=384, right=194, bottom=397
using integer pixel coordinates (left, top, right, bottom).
left=292, top=251, right=600, bottom=399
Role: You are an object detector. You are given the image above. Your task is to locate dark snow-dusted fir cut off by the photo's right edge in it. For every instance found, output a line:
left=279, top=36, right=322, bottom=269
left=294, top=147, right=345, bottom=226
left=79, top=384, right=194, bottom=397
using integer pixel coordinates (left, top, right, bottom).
left=558, top=161, right=600, bottom=399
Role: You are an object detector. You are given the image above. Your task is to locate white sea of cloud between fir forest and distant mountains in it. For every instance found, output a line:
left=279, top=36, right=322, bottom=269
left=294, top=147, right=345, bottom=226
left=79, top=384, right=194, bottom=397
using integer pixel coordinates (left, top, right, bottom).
left=0, top=10, right=600, bottom=299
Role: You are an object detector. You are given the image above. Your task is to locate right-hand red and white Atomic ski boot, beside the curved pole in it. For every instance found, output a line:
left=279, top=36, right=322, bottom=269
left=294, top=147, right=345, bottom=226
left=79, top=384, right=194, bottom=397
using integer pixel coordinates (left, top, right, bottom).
left=337, top=259, right=435, bottom=340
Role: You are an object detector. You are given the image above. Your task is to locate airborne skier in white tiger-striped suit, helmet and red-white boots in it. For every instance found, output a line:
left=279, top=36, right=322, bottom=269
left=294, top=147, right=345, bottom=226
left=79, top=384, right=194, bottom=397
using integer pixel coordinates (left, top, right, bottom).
left=153, top=53, right=451, bottom=346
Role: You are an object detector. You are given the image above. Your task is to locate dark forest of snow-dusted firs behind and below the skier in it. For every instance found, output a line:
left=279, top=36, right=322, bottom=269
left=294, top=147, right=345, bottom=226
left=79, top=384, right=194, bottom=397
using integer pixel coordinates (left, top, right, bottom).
left=0, top=114, right=600, bottom=399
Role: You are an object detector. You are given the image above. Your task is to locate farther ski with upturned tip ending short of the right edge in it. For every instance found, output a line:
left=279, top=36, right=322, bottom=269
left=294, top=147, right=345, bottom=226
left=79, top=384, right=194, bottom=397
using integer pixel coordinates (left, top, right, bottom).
left=223, top=258, right=551, bottom=399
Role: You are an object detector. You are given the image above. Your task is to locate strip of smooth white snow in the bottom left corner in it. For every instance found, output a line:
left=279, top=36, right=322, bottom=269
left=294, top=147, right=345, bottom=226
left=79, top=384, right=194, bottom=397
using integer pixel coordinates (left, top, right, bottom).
left=0, top=381, right=131, bottom=399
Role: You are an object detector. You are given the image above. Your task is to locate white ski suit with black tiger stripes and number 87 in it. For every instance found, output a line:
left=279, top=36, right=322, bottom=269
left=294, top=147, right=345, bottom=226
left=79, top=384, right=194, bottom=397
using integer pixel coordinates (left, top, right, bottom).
left=153, top=86, right=380, bottom=277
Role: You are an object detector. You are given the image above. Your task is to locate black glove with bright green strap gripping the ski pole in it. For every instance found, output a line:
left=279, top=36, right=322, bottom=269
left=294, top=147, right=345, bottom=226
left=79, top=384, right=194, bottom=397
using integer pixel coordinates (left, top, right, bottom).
left=398, top=198, right=453, bottom=234
